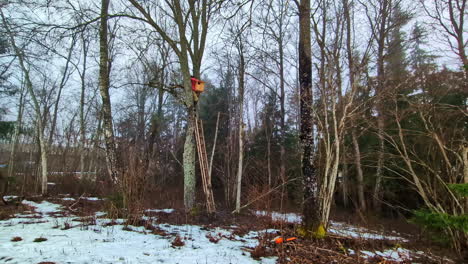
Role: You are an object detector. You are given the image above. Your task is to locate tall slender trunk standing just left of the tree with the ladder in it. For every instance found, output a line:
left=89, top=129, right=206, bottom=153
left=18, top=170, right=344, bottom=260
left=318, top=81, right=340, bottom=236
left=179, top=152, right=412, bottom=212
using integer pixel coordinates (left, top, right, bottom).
left=99, top=0, right=118, bottom=184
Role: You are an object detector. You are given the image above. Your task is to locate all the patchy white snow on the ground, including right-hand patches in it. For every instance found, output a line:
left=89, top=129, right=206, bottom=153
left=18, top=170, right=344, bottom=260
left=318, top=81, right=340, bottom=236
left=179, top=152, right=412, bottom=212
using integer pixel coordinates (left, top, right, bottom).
left=0, top=198, right=450, bottom=264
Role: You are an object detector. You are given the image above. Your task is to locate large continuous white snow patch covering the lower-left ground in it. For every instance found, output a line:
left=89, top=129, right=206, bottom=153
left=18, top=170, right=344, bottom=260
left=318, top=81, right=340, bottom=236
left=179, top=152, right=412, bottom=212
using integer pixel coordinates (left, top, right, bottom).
left=0, top=201, right=276, bottom=264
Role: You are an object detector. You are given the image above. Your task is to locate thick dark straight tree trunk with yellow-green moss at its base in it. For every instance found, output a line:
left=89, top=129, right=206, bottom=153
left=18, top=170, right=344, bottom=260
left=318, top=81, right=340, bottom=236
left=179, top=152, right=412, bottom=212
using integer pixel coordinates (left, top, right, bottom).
left=298, top=0, right=323, bottom=235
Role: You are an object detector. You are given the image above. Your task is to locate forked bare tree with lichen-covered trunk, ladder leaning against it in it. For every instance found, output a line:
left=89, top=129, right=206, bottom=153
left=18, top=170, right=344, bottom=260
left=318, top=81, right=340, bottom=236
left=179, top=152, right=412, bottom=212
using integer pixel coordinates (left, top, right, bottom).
left=128, top=0, right=223, bottom=210
